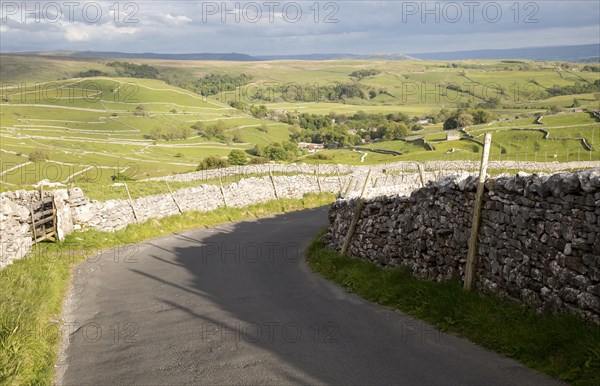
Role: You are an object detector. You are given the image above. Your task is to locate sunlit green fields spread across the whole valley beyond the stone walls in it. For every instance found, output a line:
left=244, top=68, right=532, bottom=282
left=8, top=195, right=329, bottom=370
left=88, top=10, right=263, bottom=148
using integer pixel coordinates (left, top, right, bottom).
left=0, top=55, right=600, bottom=190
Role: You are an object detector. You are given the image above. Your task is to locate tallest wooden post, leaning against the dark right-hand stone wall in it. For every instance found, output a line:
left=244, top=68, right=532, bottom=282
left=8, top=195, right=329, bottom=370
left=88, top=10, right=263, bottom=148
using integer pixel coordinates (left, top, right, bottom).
left=464, top=133, right=492, bottom=291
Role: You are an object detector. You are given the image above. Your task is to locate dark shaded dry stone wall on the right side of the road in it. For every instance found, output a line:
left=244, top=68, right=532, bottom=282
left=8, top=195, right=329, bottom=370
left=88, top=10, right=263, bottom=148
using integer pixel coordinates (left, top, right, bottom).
left=324, top=170, right=600, bottom=323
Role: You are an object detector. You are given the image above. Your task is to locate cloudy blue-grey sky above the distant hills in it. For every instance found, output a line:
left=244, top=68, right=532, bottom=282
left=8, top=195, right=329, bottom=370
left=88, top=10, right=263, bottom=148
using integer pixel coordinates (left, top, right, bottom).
left=0, top=0, right=600, bottom=55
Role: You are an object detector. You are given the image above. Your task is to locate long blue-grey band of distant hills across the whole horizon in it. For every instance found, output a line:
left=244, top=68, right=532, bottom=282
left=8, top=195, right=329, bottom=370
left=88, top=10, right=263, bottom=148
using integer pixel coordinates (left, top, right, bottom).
left=5, top=44, right=600, bottom=62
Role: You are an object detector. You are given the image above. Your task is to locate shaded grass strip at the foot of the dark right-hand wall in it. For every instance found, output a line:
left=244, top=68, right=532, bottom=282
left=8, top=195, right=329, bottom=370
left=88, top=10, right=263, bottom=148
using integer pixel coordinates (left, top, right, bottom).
left=307, top=238, right=600, bottom=386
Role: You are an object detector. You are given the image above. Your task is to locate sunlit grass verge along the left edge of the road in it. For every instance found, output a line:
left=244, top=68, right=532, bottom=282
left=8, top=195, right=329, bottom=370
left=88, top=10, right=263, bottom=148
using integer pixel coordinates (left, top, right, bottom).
left=0, top=193, right=334, bottom=385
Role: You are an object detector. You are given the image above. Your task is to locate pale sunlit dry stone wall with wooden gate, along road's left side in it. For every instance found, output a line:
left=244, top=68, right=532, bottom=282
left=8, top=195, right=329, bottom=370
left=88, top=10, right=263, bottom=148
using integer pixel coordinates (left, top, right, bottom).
left=0, top=170, right=420, bottom=269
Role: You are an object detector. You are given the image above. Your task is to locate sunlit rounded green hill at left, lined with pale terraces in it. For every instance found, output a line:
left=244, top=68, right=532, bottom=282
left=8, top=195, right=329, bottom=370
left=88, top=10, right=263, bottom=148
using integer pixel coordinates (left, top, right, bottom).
left=0, top=78, right=289, bottom=188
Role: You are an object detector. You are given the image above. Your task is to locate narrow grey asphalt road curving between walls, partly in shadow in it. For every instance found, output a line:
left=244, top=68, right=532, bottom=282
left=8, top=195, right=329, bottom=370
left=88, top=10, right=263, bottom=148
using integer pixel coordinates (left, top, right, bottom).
left=57, top=208, right=558, bottom=385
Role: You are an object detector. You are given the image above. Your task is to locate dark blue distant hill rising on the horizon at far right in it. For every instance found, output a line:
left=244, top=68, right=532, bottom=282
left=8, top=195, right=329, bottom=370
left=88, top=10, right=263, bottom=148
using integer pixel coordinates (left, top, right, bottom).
left=411, top=44, right=600, bottom=62
